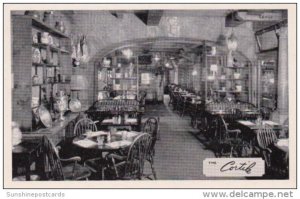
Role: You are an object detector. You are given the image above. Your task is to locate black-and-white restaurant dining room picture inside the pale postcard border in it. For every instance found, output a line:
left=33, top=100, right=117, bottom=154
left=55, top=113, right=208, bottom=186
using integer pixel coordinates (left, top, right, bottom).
left=10, top=7, right=295, bottom=181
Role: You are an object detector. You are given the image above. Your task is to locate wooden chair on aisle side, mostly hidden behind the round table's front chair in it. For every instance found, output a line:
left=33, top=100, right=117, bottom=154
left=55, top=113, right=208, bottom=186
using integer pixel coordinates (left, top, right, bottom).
left=142, top=117, right=159, bottom=180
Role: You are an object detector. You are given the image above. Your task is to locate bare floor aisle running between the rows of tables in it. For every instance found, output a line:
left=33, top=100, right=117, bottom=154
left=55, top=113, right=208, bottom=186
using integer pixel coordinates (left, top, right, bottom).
left=145, top=99, right=215, bottom=180
